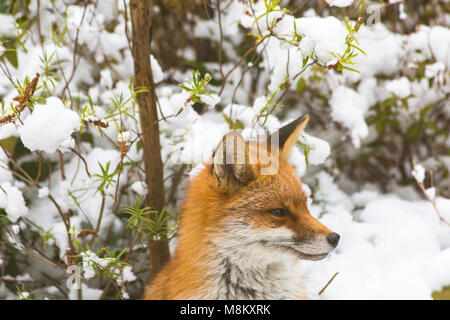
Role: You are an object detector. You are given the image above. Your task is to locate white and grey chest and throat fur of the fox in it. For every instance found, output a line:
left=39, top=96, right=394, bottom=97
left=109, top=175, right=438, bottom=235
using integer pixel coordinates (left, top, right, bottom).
left=188, top=222, right=306, bottom=300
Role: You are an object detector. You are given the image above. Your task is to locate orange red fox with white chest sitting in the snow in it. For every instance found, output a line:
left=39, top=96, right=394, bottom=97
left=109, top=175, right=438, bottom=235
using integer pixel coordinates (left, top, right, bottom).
left=143, top=115, right=339, bottom=300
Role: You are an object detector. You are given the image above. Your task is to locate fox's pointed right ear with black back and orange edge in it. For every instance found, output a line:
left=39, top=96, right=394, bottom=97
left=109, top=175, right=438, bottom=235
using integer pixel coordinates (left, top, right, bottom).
left=270, top=114, right=309, bottom=161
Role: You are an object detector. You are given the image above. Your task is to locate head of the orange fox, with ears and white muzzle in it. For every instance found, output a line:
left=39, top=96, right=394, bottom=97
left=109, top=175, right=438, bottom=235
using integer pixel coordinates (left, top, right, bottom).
left=186, top=115, right=339, bottom=260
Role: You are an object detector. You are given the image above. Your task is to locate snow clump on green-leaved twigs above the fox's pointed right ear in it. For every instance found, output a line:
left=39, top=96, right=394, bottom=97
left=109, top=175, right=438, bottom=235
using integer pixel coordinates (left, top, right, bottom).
left=240, top=1, right=351, bottom=92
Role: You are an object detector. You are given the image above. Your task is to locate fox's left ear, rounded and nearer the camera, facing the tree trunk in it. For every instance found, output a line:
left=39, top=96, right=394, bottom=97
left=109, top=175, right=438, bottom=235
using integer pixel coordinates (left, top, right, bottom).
left=211, top=132, right=254, bottom=190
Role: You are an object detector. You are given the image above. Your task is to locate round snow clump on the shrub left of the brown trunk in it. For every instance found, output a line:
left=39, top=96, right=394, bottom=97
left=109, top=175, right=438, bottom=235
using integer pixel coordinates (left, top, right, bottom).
left=19, top=97, right=80, bottom=153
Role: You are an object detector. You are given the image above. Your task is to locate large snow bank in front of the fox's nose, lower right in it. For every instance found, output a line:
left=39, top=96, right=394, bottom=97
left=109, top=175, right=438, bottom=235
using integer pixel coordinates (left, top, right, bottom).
left=303, top=173, right=450, bottom=299
